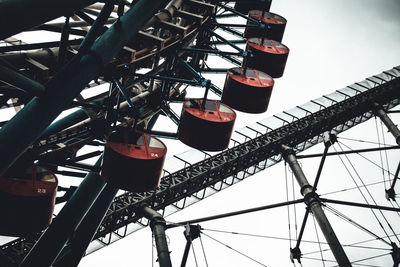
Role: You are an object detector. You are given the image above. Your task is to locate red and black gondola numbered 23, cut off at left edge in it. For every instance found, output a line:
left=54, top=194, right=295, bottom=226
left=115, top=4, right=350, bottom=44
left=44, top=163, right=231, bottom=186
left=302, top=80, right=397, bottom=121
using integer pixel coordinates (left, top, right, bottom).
left=0, top=165, right=58, bottom=236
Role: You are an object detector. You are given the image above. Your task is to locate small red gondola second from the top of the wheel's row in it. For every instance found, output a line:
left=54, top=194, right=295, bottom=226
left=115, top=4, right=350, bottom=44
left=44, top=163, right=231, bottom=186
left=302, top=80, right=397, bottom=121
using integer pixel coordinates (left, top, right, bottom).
left=244, top=10, right=287, bottom=42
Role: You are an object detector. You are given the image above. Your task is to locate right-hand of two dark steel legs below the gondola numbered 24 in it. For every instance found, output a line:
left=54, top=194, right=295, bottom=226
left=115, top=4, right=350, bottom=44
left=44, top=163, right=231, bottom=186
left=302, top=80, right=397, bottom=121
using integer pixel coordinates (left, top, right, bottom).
left=53, top=184, right=118, bottom=267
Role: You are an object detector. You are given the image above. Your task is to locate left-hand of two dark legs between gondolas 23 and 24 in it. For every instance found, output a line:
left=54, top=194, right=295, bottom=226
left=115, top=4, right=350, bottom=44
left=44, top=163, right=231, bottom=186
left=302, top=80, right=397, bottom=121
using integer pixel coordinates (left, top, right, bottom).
left=20, top=158, right=105, bottom=267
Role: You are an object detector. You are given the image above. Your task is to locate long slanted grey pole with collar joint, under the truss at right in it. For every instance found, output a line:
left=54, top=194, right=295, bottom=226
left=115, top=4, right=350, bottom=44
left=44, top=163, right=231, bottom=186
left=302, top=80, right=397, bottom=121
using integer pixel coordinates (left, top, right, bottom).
left=282, top=145, right=351, bottom=267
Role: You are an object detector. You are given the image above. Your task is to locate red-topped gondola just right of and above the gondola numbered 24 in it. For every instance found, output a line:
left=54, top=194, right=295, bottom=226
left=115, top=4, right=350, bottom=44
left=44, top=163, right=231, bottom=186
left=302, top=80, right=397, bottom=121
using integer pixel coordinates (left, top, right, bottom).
left=178, top=99, right=236, bottom=151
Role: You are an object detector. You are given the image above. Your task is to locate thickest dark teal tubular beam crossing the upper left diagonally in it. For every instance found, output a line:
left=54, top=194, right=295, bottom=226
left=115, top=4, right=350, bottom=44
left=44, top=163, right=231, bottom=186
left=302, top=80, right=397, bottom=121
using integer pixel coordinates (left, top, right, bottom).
left=0, top=0, right=170, bottom=174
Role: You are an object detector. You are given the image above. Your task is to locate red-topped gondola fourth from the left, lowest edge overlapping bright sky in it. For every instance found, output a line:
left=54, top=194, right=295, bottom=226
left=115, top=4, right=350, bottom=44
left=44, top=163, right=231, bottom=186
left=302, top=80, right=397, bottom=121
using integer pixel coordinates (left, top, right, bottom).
left=222, top=68, right=274, bottom=113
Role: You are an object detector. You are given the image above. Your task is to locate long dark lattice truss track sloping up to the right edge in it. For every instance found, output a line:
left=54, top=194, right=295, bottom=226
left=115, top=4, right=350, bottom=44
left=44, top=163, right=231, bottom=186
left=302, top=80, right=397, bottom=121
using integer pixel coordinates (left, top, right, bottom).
left=1, top=65, right=400, bottom=266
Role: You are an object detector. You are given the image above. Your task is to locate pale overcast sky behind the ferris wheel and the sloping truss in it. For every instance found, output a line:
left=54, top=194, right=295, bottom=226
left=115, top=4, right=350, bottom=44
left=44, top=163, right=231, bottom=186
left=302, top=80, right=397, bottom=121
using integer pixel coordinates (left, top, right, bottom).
left=7, top=0, right=400, bottom=266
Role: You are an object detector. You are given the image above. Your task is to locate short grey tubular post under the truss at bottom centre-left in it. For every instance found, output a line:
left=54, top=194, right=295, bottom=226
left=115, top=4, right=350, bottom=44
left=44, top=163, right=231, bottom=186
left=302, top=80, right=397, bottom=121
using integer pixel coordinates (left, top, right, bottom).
left=142, top=207, right=172, bottom=267
